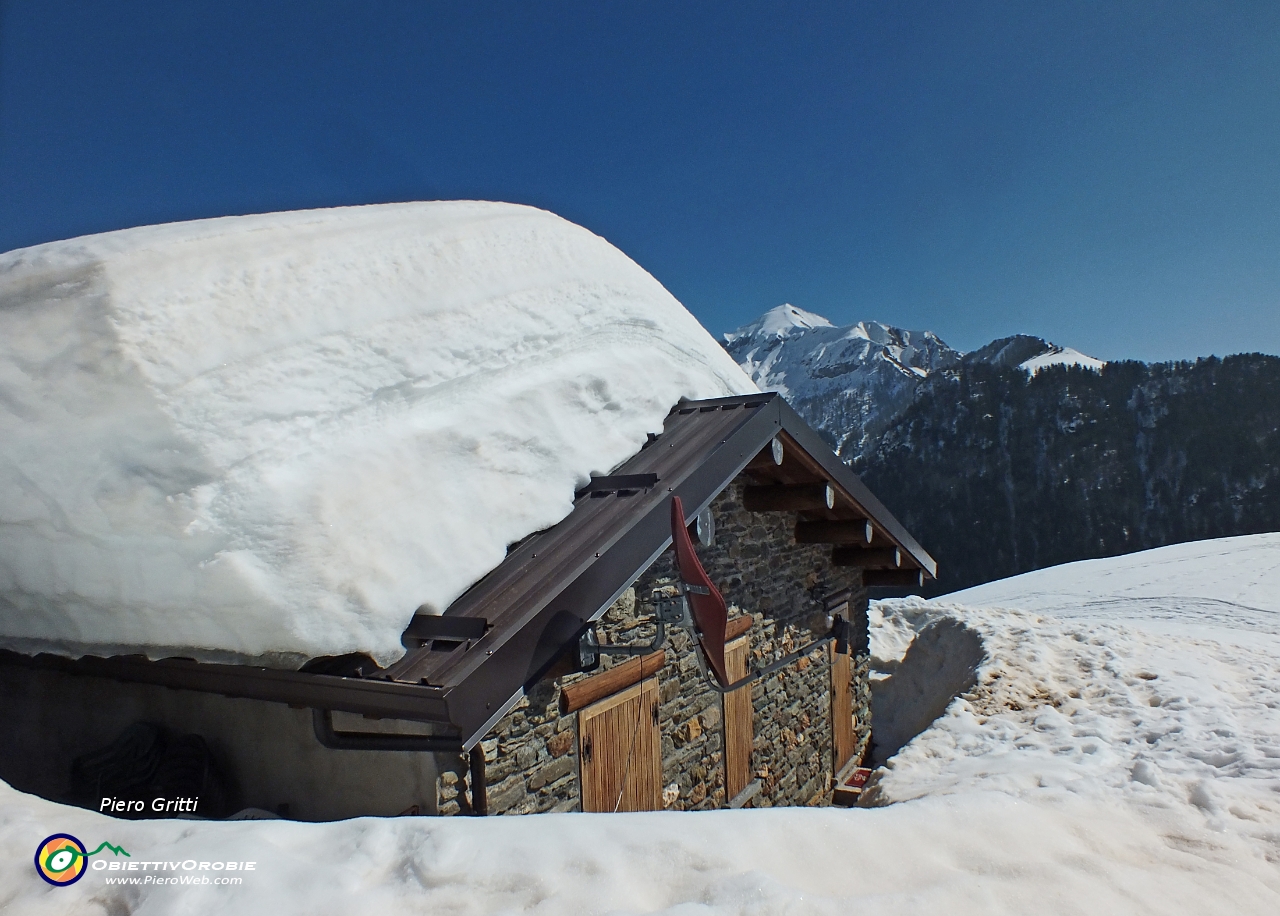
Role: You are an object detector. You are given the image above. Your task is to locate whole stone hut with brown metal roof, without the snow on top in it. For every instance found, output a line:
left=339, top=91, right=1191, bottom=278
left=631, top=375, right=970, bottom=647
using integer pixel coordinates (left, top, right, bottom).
left=0, top=394, right=937, bottom=820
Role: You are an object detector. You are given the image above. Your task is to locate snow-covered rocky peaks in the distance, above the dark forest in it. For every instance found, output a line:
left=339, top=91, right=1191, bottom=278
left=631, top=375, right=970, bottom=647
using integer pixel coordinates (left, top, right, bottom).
left=724, top=304, right=1103, bottom=461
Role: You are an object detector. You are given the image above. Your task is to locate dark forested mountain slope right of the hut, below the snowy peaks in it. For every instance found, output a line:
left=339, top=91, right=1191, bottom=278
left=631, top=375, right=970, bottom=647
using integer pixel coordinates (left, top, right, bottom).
left=849, top=353, right=1280, bottom=591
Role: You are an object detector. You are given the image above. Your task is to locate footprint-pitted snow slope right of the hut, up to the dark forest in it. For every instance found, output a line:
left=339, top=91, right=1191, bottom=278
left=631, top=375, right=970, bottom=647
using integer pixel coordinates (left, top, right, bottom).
left=873, top=533, right=1280, bottom=823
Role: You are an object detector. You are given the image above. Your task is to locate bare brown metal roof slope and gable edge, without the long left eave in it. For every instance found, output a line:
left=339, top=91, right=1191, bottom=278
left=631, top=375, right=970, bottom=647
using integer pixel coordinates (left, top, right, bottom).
left=376, top=393, right=937, bottom=741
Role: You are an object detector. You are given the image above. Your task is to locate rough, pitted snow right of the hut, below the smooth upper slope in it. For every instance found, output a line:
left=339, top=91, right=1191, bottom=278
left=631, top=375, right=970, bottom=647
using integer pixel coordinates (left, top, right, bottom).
left=877, top=604, right=1280, bottom=862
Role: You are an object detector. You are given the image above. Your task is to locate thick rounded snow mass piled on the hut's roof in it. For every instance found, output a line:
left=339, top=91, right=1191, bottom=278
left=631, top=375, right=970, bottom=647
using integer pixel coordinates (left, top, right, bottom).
left=0, top=202, right=756, bottom=664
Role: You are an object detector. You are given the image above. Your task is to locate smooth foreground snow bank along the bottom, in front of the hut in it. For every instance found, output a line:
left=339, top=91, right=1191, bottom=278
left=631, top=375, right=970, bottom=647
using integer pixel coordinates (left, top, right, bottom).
left=0, top=784, right=1280, bottom=916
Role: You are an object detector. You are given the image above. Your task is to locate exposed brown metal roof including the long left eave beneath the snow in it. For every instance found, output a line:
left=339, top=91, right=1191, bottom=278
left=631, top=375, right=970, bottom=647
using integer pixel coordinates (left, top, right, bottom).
left=5, top=393, right=937, bottom=747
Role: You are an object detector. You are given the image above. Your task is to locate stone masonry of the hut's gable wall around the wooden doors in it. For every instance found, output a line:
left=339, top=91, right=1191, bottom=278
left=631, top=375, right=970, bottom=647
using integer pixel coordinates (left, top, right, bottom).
left=438, top=482, right=870, bottom=814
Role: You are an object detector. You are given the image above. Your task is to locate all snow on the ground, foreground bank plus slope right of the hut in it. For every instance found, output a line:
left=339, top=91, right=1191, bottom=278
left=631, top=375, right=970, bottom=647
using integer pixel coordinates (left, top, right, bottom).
left=0, top=535, right=1280, bottom=916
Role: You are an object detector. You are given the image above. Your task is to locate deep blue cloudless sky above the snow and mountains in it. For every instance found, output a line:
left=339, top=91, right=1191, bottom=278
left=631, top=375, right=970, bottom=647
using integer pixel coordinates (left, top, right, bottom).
left=0, top=0, right=1280, bottom=359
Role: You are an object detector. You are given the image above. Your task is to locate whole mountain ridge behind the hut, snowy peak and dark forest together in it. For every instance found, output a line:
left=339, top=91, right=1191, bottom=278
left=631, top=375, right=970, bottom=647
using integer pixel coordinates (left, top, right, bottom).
left=724, top=306, right=1280, bottom=595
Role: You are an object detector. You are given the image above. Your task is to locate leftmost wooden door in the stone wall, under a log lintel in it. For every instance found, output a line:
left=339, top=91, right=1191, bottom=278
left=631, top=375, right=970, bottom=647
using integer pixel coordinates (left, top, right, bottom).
left=577, top=678, right=662, bottom=811
